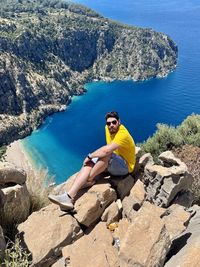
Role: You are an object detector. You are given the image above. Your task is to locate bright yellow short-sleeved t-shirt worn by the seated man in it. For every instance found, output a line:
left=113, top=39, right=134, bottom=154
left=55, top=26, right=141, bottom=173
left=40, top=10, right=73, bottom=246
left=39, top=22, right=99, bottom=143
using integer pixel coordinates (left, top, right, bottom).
left=105, top=124, right=135, bottom=172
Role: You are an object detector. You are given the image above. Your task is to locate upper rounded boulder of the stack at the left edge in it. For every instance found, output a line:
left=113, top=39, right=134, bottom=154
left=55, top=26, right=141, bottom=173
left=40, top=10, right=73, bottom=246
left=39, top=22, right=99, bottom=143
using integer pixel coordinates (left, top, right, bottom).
left=0, top=162, right=26, bottom=186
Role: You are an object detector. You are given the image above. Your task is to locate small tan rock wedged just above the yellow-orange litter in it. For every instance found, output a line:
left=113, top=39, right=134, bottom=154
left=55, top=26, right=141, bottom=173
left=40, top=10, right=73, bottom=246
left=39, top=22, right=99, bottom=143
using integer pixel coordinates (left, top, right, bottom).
left=101, top=202, right=121, bottom=225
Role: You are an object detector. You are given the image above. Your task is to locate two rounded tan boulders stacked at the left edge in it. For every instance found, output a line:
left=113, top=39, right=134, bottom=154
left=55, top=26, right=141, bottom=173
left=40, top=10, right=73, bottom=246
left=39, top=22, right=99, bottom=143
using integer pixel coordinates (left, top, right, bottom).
left=0, top=162, right=30, bottom=228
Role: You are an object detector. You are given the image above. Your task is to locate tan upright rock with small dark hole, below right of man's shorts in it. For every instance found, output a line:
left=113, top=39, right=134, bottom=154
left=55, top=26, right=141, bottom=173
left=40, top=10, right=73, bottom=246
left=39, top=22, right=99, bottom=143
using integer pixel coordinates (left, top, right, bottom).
left=122, top=180, right=146, bottom=220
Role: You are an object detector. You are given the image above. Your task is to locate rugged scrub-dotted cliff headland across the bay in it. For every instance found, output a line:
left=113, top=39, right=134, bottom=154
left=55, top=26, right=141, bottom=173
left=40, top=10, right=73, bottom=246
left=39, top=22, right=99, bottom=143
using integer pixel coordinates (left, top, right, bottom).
left=0, top=1, right=177, bottom=144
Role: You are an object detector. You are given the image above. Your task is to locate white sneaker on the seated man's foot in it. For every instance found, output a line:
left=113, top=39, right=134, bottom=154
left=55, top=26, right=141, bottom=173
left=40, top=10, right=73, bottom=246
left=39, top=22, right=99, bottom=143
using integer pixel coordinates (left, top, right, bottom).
left=48, top=193, right=74, bottom=211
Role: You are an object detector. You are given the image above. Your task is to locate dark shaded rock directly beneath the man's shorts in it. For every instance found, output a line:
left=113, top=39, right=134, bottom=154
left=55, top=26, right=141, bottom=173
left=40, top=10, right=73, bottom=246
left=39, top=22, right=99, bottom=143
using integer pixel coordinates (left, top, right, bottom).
left=109, top=175, right=135, bottom=200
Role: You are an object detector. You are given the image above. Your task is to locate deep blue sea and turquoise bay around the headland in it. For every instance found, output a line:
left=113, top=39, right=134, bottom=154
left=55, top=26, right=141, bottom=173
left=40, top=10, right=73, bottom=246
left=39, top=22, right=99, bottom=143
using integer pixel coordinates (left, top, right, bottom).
left=23, top=0, right=200, bottom=183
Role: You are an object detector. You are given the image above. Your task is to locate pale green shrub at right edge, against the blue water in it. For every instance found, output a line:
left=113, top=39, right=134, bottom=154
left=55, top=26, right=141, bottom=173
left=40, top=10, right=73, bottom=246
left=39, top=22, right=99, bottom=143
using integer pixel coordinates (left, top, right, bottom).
left=139, top=114, right=200, bottom=160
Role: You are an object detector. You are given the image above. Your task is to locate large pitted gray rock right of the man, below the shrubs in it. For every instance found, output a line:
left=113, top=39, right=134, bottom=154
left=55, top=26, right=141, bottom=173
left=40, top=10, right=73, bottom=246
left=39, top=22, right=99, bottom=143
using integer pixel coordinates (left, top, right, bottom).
left=144, top=151, right=193, bottom=207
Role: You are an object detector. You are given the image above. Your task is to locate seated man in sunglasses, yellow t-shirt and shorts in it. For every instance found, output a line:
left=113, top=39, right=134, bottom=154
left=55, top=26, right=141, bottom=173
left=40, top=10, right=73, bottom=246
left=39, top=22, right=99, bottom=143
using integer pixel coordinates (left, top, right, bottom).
left=49, top=111, right=135, bottom=210
